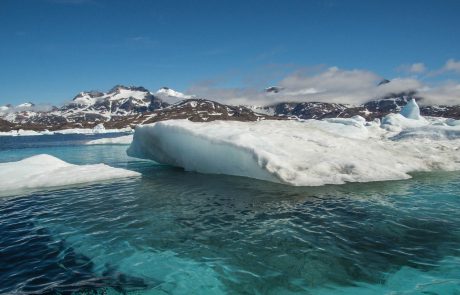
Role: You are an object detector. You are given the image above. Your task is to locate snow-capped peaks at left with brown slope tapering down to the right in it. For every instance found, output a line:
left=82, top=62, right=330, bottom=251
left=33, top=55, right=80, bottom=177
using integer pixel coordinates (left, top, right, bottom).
left=0, top=85, right=274, bottom=131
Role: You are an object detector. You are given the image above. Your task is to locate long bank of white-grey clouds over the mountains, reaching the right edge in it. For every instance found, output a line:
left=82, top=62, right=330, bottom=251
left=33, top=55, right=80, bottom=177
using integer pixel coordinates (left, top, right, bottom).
left=187, top=59, right=460, bottom=105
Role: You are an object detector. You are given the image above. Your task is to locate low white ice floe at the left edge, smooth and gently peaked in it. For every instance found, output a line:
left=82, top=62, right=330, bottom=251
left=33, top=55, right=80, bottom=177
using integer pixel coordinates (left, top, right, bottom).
left=0, top=154, right=140, bottom=195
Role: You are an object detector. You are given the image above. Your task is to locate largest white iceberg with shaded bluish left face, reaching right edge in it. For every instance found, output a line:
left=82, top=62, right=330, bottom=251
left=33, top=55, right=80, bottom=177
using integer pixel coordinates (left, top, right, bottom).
left=128, top=115, right=460, bottom=186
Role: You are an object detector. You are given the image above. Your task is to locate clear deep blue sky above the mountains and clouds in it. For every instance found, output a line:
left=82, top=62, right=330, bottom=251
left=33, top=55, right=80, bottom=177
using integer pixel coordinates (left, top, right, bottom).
left=0, top=0, right=460, bottom=104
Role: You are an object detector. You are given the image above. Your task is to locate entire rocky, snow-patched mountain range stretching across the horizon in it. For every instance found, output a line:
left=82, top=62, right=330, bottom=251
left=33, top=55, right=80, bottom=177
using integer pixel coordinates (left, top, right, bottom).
left=0, top=82, right=460, bottom=132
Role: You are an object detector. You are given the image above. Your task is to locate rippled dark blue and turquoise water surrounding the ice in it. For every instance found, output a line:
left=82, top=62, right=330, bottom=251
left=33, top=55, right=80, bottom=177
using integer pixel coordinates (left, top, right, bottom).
left=0, top=136, right=460, bottom=294
